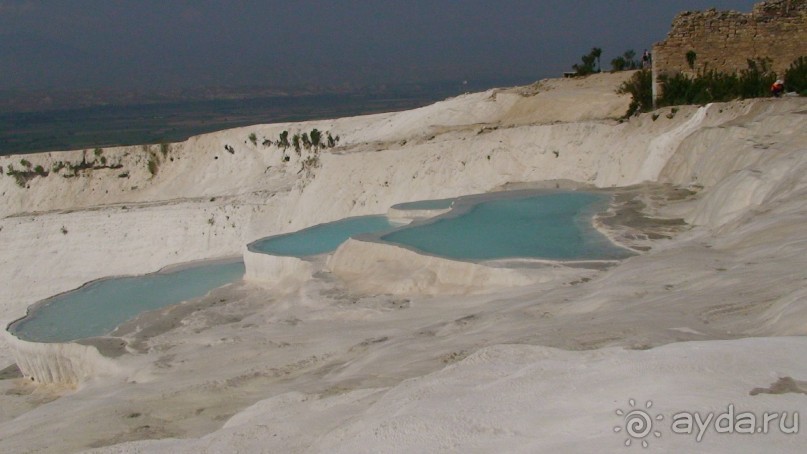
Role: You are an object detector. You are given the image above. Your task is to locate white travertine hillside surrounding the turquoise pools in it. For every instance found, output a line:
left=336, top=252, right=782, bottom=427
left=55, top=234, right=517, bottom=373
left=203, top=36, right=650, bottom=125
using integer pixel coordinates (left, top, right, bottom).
left=0, top=75, right=807, bottom=451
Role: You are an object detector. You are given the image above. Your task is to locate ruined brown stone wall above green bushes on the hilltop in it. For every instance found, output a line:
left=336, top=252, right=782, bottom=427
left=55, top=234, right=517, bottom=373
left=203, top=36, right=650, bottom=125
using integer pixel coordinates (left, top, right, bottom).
left=653, top=0, right=807, bottom=97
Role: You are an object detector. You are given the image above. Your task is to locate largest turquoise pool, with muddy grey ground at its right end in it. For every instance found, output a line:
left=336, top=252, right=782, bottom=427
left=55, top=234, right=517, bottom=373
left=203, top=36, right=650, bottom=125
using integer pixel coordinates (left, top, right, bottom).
left=381, top=192, right=632, bottom=260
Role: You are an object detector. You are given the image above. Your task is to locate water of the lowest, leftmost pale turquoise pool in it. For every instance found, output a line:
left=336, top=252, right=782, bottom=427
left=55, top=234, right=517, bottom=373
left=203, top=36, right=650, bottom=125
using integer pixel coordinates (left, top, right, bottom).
left=8, top=261, right=244, bottom=342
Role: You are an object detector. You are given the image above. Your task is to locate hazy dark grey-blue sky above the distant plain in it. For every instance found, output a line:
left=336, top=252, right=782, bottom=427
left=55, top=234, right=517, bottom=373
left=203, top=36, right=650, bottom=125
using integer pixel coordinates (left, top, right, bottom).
left=0, top=0, right=754, bottom=89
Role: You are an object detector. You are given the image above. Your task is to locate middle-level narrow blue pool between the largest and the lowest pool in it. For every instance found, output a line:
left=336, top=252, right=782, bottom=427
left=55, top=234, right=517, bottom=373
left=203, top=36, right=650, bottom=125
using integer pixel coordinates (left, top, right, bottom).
left=249, top=215, right=398, bottom=257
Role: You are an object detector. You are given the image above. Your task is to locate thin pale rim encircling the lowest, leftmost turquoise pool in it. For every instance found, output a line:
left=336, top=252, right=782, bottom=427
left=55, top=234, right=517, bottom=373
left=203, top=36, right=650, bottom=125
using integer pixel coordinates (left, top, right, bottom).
left=3, top=255, right=244, bottom=344
